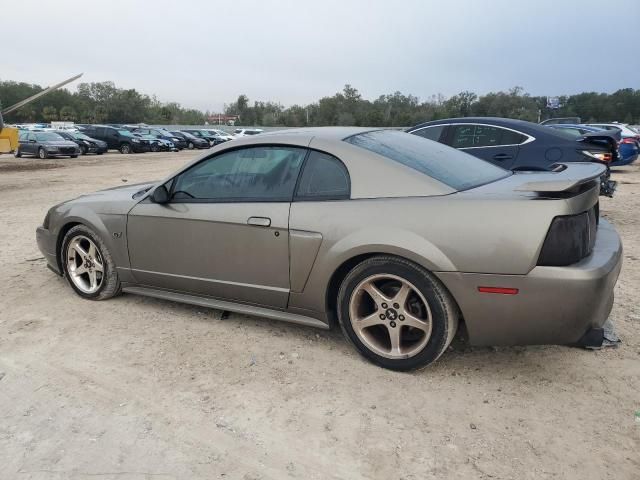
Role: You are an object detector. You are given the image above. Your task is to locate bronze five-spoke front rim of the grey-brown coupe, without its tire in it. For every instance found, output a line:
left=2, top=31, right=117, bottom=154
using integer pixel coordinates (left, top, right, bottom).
left=66, top=235, right=104, bottom=294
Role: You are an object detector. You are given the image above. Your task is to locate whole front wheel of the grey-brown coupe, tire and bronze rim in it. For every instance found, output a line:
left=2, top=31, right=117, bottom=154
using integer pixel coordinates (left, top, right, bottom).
left=60, top=225, right=120, bottom=300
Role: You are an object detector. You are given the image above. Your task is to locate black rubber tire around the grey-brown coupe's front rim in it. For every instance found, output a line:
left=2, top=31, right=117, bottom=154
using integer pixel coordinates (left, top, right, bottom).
left=58, top=225, right=120, bottom=300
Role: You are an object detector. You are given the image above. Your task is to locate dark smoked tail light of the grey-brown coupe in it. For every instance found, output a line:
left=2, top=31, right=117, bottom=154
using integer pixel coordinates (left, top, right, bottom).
left=538, top=205, right=598, bottom=267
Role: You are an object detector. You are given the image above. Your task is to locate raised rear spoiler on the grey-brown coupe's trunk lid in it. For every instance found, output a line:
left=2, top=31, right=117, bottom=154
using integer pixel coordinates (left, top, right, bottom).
left=514, top=162, right=607, bottom=192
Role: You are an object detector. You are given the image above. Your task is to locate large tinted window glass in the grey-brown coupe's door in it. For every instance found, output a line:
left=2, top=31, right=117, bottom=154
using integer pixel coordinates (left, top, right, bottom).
left=172, top=146, right=307, bottom=202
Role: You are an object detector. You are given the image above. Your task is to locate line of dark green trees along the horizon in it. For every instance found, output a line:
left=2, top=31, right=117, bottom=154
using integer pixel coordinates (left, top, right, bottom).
left=0, top=77, right=640, bottom=127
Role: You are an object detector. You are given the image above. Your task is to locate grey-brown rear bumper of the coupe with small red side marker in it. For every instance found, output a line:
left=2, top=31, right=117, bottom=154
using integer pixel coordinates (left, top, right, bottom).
left=437, top=219, right=622, bottom=345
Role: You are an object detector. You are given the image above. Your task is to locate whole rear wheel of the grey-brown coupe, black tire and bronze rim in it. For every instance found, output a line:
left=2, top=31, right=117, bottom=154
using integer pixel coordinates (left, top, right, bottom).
left=337, top=255, right=459, bottom=371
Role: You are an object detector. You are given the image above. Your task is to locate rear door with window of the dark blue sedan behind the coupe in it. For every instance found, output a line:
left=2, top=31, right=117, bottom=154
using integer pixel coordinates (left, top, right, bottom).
left=446, top=123, right=527, bottom=169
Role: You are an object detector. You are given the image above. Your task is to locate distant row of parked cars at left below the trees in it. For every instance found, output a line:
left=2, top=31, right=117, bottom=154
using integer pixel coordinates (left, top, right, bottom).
left=15, top=124, right=250, bottom=158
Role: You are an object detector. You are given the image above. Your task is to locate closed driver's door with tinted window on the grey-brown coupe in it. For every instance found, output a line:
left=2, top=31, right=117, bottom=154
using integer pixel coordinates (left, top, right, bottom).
left=127, top=146, right=306, bottom=308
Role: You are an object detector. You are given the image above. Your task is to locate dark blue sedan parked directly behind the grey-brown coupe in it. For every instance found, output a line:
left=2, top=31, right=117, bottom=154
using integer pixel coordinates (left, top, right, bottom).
left=407, top=117, right=619, bottom=196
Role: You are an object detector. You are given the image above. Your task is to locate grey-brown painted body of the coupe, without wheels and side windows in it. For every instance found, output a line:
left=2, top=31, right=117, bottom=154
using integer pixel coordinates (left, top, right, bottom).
left=37, top=127, right=622, bottom=345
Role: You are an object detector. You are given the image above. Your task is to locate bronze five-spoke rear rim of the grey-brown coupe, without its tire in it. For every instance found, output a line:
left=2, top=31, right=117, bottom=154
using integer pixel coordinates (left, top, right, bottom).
left=349, top=274, right=432, bottom=359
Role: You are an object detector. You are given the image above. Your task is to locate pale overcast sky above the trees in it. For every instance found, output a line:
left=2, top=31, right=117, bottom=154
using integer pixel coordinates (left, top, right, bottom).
left=5, top=0, right=640, bottom=111
